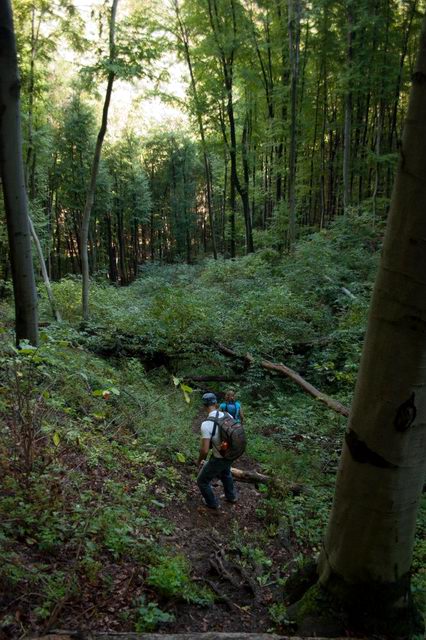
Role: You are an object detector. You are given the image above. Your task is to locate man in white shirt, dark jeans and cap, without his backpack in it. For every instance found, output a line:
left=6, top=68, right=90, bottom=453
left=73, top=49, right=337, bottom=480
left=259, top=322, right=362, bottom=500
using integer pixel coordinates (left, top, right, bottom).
left=197, top=393, right=237, bottom=509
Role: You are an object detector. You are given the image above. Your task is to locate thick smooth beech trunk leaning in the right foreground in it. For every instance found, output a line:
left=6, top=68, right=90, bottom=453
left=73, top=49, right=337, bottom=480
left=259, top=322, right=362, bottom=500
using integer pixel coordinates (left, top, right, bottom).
left=299, top=19, right=426, bottom=637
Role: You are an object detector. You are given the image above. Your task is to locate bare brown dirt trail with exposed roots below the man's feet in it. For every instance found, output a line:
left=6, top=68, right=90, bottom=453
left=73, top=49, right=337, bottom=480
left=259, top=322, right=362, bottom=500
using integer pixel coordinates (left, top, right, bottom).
left=158, top=414, right=288, bottom=633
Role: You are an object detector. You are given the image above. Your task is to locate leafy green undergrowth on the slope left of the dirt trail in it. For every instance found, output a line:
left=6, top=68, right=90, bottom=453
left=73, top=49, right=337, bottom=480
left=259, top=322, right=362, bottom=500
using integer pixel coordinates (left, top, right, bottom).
left=0, top=325, right=200, bottom=625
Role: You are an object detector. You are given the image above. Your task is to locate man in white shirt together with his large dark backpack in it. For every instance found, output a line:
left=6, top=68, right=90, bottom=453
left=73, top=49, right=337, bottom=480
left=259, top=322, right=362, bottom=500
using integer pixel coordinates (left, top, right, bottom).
left=197, top=393, right=246, bottom=509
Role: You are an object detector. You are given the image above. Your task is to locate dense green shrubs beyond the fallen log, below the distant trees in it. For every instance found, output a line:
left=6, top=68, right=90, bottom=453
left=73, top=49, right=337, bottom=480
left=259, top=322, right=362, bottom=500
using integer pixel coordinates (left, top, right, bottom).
left=44, top=215, right=376, bottom=402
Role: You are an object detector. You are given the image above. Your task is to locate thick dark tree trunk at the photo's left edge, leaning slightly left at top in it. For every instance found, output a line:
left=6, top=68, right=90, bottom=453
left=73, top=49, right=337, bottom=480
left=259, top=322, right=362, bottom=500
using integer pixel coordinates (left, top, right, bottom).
left=0, top=0, right=38, bottom=345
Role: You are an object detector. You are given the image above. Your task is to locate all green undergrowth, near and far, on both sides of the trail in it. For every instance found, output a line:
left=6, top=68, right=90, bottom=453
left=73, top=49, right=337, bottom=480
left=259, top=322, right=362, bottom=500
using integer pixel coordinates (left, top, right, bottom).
left=0, top=217, right=426, bottom=637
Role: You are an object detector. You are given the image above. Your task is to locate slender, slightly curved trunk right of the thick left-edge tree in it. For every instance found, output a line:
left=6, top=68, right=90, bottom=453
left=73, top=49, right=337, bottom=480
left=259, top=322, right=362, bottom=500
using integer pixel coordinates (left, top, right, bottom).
left=80, top=0, right=118, bottom=320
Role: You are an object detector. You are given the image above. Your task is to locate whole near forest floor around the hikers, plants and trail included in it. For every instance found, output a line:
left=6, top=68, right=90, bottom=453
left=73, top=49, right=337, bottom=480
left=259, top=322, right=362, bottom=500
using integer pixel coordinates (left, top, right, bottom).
left=0, top=308, right=426, bottom=640
